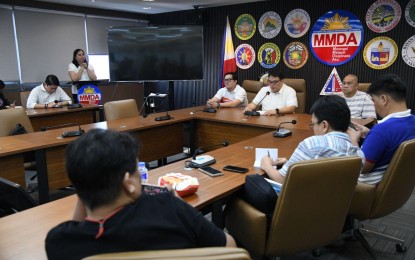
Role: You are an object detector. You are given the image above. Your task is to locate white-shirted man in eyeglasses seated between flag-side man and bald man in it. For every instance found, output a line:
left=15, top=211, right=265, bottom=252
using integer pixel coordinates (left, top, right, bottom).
left=245, top=72, right=298, bottom=116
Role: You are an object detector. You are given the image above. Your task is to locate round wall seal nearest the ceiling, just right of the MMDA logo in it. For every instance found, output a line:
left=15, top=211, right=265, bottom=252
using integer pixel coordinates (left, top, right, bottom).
left=366, top=0, right=402, bottom=33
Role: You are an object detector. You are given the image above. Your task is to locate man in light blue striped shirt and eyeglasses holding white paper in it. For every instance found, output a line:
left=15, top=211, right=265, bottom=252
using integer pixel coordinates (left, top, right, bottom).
left=261, top=95, right=365, bottom=183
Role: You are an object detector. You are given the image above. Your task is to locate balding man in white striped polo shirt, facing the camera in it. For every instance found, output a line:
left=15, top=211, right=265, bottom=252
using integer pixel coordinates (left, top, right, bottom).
left=342, top=74, right=376, bottom=119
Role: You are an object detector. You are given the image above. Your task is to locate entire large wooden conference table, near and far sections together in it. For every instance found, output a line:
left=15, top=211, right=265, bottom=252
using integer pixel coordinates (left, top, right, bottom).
left=0, top=107, right=376, bottom=259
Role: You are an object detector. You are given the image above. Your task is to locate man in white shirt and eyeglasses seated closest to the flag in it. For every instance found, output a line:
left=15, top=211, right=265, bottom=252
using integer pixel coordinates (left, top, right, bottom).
left=206, top=72, right=248, bottom=108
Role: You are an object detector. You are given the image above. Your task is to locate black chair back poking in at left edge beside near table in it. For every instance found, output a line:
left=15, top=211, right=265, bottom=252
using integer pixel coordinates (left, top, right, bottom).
left=0, top=177, right=36, bottom=217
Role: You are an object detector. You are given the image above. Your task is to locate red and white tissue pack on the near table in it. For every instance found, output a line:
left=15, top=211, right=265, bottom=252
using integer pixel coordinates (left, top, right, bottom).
left=158, top=172, right=199, bottom=197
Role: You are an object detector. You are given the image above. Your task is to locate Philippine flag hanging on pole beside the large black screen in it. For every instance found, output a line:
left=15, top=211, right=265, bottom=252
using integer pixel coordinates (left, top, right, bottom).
left=219, top=17, right=236, bottom=87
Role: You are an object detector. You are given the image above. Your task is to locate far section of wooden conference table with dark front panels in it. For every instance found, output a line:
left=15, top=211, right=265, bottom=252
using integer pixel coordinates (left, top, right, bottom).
left=0, top=107, right=310, bottom=203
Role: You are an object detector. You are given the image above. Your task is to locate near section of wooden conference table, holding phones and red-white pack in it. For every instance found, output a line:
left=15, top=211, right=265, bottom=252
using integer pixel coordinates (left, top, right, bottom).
left=0, top=128, right=312, bottom=259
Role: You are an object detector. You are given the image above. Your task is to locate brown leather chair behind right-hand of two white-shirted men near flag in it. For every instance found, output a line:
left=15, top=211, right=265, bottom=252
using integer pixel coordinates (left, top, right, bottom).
left=242, top=78, right=307, bottom=114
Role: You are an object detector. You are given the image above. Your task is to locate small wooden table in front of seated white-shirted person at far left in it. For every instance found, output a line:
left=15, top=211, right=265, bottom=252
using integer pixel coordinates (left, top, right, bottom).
left=26, top=104, right=105, bottom=131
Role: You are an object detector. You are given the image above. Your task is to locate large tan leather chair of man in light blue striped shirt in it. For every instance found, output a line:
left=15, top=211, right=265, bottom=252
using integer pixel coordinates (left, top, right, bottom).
left=225, top=156, right=362, bottom=257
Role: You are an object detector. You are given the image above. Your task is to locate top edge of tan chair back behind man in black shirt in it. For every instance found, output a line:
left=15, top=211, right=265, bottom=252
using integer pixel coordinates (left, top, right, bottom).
left=84, top=247, right=251, bottom=260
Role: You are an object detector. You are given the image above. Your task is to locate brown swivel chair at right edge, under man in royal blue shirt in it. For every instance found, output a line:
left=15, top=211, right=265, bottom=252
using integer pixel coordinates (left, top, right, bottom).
left=349, top=139, right=415, bottom=258
